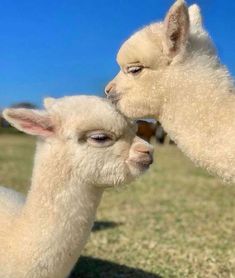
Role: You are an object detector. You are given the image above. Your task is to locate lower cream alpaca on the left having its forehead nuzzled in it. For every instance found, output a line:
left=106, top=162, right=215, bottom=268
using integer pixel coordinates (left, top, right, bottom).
left=0, top=96, right=153, bottom=278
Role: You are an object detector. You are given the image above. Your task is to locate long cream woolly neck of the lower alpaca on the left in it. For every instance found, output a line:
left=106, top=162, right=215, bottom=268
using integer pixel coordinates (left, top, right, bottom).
left=14, top=142, right=103, bottom=278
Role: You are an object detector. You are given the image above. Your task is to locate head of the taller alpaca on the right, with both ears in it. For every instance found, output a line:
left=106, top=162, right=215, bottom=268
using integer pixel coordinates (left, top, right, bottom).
left=105, top=0, right=217, bottom=118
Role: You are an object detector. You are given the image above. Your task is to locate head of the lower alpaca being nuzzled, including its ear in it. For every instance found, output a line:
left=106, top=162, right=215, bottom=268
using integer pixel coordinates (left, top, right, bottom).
left=3, top=96, right=153, bottom=189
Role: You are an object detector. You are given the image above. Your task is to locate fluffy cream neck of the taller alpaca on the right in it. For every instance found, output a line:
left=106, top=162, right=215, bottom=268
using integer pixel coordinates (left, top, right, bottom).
left=159, top=57, right=235, bottom=180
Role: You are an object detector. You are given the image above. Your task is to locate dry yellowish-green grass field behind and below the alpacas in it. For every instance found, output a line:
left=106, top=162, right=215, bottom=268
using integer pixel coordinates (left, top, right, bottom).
left=0, top=134, right=235, bottom=278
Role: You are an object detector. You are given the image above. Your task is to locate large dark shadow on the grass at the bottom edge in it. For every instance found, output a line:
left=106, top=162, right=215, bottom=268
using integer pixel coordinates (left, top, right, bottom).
left=69, top=256, right=162, bottom=278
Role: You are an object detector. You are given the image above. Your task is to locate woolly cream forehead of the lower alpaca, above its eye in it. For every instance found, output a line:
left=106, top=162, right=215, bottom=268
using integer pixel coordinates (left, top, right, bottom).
left=52, top=96, right=129, bottom=135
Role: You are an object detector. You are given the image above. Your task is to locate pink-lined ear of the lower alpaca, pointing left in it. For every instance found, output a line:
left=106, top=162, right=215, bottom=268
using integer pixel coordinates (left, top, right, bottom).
left=3, top=108, right=54, bottom=138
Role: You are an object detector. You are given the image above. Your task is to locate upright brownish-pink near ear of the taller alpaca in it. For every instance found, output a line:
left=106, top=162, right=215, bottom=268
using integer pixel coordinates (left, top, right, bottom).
left=164, top=0, right=189, bottom=57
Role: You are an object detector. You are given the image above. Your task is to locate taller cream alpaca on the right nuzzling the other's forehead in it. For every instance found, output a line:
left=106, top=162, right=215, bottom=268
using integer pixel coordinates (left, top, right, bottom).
left=106, top=0, right=235, bottom=182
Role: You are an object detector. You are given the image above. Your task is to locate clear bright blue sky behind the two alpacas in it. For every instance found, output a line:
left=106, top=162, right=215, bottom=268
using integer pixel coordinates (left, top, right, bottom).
left=0, top=0, right=235, bottom=107
